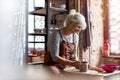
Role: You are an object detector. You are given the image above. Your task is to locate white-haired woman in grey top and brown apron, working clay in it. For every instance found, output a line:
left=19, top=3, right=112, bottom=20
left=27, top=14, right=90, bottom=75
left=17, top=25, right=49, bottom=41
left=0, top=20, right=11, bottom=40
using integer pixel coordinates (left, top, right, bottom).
left=45, top=10, right=103, bottom=74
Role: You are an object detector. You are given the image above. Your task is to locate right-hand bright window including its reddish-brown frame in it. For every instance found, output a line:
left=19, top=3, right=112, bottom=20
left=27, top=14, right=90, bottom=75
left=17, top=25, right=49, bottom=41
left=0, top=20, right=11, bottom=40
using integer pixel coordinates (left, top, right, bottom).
left=105, top=0, right=120, bottom=55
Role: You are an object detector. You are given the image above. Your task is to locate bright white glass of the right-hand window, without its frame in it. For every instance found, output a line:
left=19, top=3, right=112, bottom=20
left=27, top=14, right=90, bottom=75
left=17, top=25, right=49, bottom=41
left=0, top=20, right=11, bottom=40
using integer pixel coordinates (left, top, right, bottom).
left=109, top=0, right=120, bottom=54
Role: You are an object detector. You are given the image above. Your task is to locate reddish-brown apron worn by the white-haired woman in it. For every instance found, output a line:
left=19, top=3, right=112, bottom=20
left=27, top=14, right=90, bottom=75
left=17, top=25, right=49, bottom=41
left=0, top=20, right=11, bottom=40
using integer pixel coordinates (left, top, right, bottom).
left=44, top=31, right=75, bottom=69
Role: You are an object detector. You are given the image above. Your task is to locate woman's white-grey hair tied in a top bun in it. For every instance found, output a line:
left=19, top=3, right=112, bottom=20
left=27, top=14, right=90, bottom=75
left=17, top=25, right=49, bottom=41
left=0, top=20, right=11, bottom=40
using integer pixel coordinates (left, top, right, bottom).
left=64, top=9, right=86, bottom=30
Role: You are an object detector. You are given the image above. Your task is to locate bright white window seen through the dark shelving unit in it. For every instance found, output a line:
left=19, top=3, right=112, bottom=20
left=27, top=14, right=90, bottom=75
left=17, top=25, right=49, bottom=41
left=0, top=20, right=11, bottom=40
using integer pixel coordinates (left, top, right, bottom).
left=28, top=0, right=45, bottom=50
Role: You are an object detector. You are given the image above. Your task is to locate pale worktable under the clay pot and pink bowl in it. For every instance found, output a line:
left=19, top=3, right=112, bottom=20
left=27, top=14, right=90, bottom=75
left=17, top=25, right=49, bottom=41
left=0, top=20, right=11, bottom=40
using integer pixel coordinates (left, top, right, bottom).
left=63, top=67, right=120, bottom=80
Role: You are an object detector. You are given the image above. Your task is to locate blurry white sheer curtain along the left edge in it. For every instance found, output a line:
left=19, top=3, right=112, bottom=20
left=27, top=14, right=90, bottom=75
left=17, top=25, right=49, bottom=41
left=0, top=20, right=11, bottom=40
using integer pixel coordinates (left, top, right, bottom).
left=0, top=0, right=26, bottom=66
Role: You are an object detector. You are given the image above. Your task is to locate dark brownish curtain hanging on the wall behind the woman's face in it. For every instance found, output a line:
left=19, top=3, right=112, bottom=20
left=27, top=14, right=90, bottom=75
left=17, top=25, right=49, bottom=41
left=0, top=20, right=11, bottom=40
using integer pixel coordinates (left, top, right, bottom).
left=79, top=0, right=92, bottom=62
